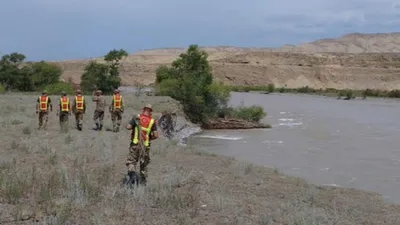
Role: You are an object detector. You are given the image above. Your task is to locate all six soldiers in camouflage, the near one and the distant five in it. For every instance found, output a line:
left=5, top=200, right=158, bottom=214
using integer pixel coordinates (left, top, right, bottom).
left=36, top=88, right=159, bottom=184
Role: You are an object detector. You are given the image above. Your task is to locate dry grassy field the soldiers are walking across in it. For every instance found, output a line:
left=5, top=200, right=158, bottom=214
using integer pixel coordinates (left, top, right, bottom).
left=0, top=94, right=400, bottom=225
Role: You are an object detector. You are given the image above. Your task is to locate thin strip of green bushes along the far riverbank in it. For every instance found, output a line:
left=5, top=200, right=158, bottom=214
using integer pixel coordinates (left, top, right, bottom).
left=228, top=84, right=400, bottom=99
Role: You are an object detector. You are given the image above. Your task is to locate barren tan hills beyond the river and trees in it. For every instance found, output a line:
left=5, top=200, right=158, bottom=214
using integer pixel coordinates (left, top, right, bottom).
left=55, top=33, right=400, bottom=89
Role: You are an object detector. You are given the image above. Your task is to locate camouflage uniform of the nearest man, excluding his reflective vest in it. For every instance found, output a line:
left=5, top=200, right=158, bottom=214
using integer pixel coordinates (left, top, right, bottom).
left=126, top=104, right=157, bottom=181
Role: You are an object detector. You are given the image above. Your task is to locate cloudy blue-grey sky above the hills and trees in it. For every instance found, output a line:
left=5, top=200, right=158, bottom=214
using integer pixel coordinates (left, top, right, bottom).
left=0, top=0, right=400, bottom=60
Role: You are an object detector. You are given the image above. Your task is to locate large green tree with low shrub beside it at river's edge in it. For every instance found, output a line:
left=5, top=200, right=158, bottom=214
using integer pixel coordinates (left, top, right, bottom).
left=156, top=45, right=265, bottom=124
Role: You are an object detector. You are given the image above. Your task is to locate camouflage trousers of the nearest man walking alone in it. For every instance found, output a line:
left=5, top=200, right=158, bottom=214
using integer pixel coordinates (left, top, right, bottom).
left=126, top=144, right=151, bottom=178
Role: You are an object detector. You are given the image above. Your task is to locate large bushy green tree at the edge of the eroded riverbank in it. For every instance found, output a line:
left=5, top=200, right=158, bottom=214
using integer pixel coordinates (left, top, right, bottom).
left=156, top=45, right=218, bottom=123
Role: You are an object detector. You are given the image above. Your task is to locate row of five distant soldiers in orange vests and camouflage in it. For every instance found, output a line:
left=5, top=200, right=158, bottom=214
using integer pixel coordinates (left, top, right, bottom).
left=36, top=89, right=124, bottom=132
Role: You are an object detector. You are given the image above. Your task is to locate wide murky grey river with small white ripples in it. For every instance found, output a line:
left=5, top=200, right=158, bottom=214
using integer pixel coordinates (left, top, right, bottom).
left=188, top=93, right=400, bottom=203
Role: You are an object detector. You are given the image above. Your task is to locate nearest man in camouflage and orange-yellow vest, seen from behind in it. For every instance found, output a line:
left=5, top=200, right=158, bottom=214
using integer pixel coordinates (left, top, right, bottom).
left=126, top=104, right=158, bottom=184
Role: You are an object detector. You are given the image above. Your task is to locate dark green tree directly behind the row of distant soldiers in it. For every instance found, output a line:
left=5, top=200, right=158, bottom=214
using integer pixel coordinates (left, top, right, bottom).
left=81, top=49, right=128, bottom=93
